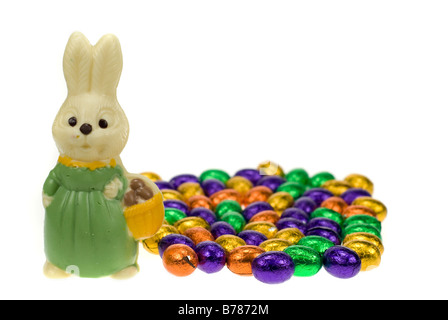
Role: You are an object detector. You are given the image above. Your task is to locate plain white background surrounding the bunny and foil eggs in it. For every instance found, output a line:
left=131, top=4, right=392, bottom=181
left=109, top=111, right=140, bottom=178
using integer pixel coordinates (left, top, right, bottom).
left=0, top=0, right=448, bottom=300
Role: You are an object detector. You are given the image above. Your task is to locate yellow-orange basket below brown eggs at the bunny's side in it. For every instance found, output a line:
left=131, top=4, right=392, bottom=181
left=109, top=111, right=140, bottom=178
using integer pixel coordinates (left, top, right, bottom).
left=124, top=192, right=165, bottom=240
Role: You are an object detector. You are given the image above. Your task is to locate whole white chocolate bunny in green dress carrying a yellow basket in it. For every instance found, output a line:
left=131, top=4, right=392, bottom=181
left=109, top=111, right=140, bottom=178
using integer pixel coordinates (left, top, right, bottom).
left=43, top=32, right=164, bottom=279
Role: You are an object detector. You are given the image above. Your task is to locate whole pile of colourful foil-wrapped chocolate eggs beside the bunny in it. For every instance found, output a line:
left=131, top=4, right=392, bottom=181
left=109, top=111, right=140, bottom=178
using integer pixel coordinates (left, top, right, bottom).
left=142, top=162, right=387, bottom=284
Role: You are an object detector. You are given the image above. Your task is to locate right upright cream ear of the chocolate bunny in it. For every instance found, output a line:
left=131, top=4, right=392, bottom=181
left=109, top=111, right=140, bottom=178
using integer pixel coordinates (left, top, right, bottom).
left=91, top=34, right=123, bottom=96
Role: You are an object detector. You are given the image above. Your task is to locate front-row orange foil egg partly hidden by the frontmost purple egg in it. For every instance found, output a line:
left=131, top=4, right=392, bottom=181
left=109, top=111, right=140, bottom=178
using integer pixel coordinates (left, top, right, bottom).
left=227, top=245, right=264, bottom=276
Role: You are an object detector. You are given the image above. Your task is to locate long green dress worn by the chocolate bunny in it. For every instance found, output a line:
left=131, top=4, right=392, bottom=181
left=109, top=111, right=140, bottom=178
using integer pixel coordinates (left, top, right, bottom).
left=44, top=163, right=138, bottom=278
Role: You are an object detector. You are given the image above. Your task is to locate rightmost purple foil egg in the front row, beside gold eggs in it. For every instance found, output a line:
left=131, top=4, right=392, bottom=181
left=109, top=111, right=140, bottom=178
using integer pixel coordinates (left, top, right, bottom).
left=323, top=246, right=361, bottom=279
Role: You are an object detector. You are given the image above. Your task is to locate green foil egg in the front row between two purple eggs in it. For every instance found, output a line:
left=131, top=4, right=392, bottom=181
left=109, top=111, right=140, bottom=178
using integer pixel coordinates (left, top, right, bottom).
left=283, top=245, right=322, bottom=277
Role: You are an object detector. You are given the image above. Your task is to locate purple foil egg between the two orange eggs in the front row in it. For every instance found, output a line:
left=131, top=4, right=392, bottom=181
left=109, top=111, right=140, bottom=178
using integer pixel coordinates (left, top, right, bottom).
left=196, top=241, right=226, bottom=273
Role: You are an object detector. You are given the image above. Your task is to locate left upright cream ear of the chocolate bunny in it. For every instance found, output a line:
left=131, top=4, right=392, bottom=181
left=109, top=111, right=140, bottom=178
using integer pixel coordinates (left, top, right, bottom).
left=63, top=32, right=93, bottom=95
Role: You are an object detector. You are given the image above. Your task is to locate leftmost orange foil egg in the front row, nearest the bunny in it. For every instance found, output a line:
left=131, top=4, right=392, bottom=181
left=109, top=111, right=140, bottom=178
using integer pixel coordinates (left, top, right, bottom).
left=162, top=244, right=199, bottom=277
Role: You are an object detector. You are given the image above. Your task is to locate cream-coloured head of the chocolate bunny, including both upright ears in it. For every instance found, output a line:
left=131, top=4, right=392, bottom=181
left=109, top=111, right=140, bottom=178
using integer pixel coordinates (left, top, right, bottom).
left=53, top=33, right=129, bottom=162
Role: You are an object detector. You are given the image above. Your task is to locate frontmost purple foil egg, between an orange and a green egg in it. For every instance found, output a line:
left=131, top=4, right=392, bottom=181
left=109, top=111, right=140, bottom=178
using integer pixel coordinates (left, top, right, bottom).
left=252, top=251, right=295, bottom=284
